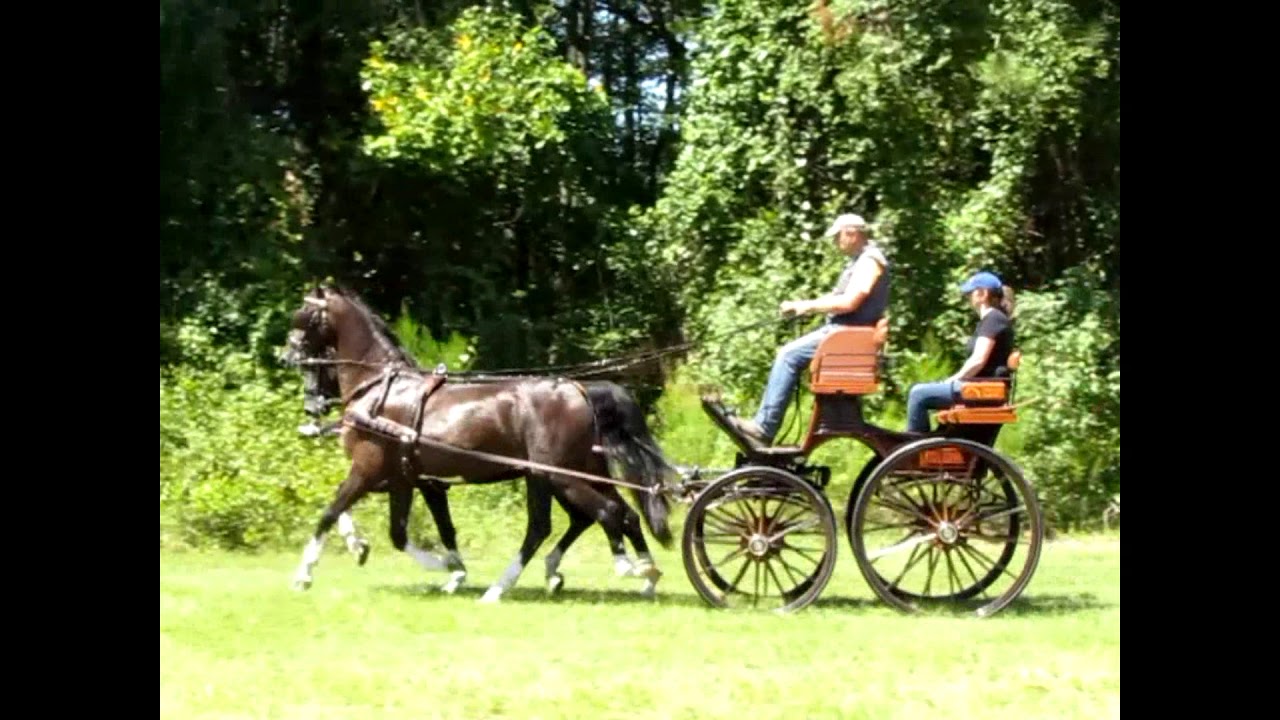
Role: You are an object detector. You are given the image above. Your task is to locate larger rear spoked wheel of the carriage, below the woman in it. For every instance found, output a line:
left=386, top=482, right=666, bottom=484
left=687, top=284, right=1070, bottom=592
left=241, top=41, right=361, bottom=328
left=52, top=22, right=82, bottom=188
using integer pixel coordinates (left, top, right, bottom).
left=847, top=438, right=1044, bottom=618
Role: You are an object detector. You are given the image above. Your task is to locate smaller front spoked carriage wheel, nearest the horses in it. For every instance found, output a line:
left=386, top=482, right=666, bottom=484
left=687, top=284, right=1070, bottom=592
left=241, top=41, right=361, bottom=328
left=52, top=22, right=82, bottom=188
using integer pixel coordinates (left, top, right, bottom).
left=684, top=468, right=837, bottom=612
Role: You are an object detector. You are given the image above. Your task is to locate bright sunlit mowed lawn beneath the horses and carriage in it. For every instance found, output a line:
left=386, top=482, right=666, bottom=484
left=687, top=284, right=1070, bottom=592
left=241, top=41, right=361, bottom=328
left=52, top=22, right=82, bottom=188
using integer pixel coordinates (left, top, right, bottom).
left=160, top=527, right=1120, bottom=720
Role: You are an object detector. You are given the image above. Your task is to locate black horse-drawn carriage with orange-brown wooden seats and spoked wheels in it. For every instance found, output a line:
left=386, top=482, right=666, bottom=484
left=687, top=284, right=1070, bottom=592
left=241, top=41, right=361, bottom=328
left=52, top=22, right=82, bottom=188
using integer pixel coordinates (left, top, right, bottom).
left=682, top=322, right=1043, bottom=616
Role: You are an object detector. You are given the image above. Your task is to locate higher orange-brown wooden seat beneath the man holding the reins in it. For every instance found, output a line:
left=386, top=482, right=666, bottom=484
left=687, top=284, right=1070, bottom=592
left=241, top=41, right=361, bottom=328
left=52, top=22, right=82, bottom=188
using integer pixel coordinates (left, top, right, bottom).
left=809, top=318, right=888, bottom=395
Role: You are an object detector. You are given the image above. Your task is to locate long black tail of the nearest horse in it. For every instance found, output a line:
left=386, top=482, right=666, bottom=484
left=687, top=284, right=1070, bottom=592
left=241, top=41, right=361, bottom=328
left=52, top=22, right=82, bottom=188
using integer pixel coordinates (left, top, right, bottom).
left=585, top=380, right=672, bottom=547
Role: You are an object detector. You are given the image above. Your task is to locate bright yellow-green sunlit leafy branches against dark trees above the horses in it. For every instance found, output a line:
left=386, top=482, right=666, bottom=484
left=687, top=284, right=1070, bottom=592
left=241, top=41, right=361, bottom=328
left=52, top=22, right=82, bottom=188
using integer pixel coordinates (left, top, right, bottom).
left=361, top=8, right=608, bottom=186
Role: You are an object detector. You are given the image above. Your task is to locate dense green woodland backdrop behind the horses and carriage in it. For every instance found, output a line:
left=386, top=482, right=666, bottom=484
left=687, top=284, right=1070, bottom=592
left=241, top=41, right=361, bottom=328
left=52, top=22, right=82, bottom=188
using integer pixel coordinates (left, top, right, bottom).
left=160, top=0, right=1120, bottom=538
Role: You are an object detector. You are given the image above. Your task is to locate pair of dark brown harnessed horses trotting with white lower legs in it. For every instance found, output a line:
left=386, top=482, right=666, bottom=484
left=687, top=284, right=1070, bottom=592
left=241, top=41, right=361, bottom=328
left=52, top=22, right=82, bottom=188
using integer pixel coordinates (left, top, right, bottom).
left=285, top=286, right=672, bottom=602
